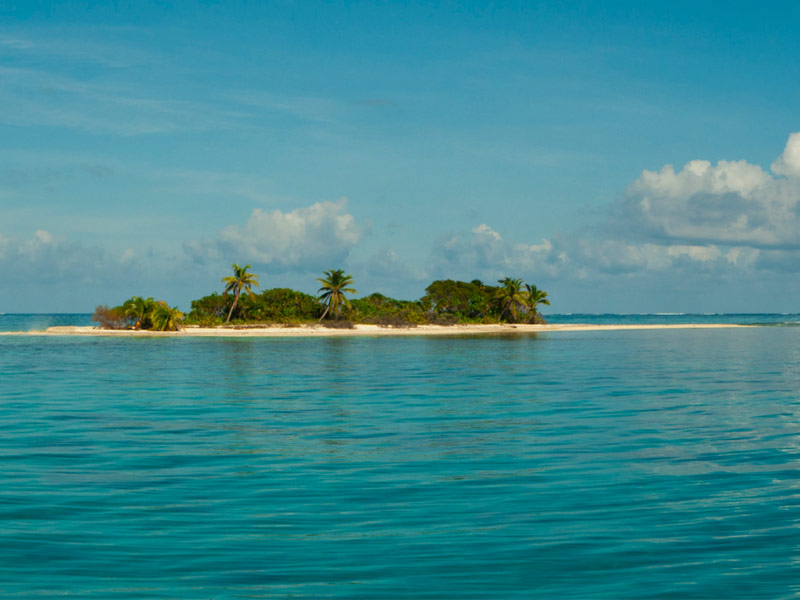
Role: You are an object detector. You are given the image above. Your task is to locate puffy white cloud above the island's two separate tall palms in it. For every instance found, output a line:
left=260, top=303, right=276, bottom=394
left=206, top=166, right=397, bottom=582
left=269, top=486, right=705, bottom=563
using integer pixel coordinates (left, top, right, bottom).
left=192, top=198, right=361, bottom=271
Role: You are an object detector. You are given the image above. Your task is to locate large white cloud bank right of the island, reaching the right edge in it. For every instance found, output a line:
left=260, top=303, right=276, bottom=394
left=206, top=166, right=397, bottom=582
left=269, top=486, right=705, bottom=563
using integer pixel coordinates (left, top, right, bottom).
left=431, top=133, right=800, bottom=288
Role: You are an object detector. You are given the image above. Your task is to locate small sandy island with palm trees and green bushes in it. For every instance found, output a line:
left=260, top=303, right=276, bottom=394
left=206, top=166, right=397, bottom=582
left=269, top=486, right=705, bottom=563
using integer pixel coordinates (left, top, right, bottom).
left=0, top=264, right=746, bottom=337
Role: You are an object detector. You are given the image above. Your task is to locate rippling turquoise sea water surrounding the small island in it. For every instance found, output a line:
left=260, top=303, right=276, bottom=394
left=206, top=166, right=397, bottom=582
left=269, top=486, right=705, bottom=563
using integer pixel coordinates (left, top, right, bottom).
left=0, top=315, right=800, bottom=599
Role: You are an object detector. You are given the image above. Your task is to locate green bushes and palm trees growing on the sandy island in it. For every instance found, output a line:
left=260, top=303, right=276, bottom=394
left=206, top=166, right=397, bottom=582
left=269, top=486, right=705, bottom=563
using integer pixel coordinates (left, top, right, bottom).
left=92, top=264, right=550, bottom=331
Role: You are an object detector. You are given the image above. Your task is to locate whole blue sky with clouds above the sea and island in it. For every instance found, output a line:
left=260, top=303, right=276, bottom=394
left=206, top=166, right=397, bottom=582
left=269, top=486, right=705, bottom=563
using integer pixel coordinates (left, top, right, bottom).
left=0, top=1, right=800, bottom=312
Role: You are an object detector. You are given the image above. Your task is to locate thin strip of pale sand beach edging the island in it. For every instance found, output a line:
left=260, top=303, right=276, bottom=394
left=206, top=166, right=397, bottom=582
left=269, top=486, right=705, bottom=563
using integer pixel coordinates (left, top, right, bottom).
left=0, top=323, right=758, bottom=338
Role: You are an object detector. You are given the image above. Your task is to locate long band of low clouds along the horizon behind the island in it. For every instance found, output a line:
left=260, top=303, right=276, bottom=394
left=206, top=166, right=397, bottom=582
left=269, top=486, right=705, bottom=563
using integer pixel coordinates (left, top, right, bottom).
left=6, top=133, right=800, bottom=310
